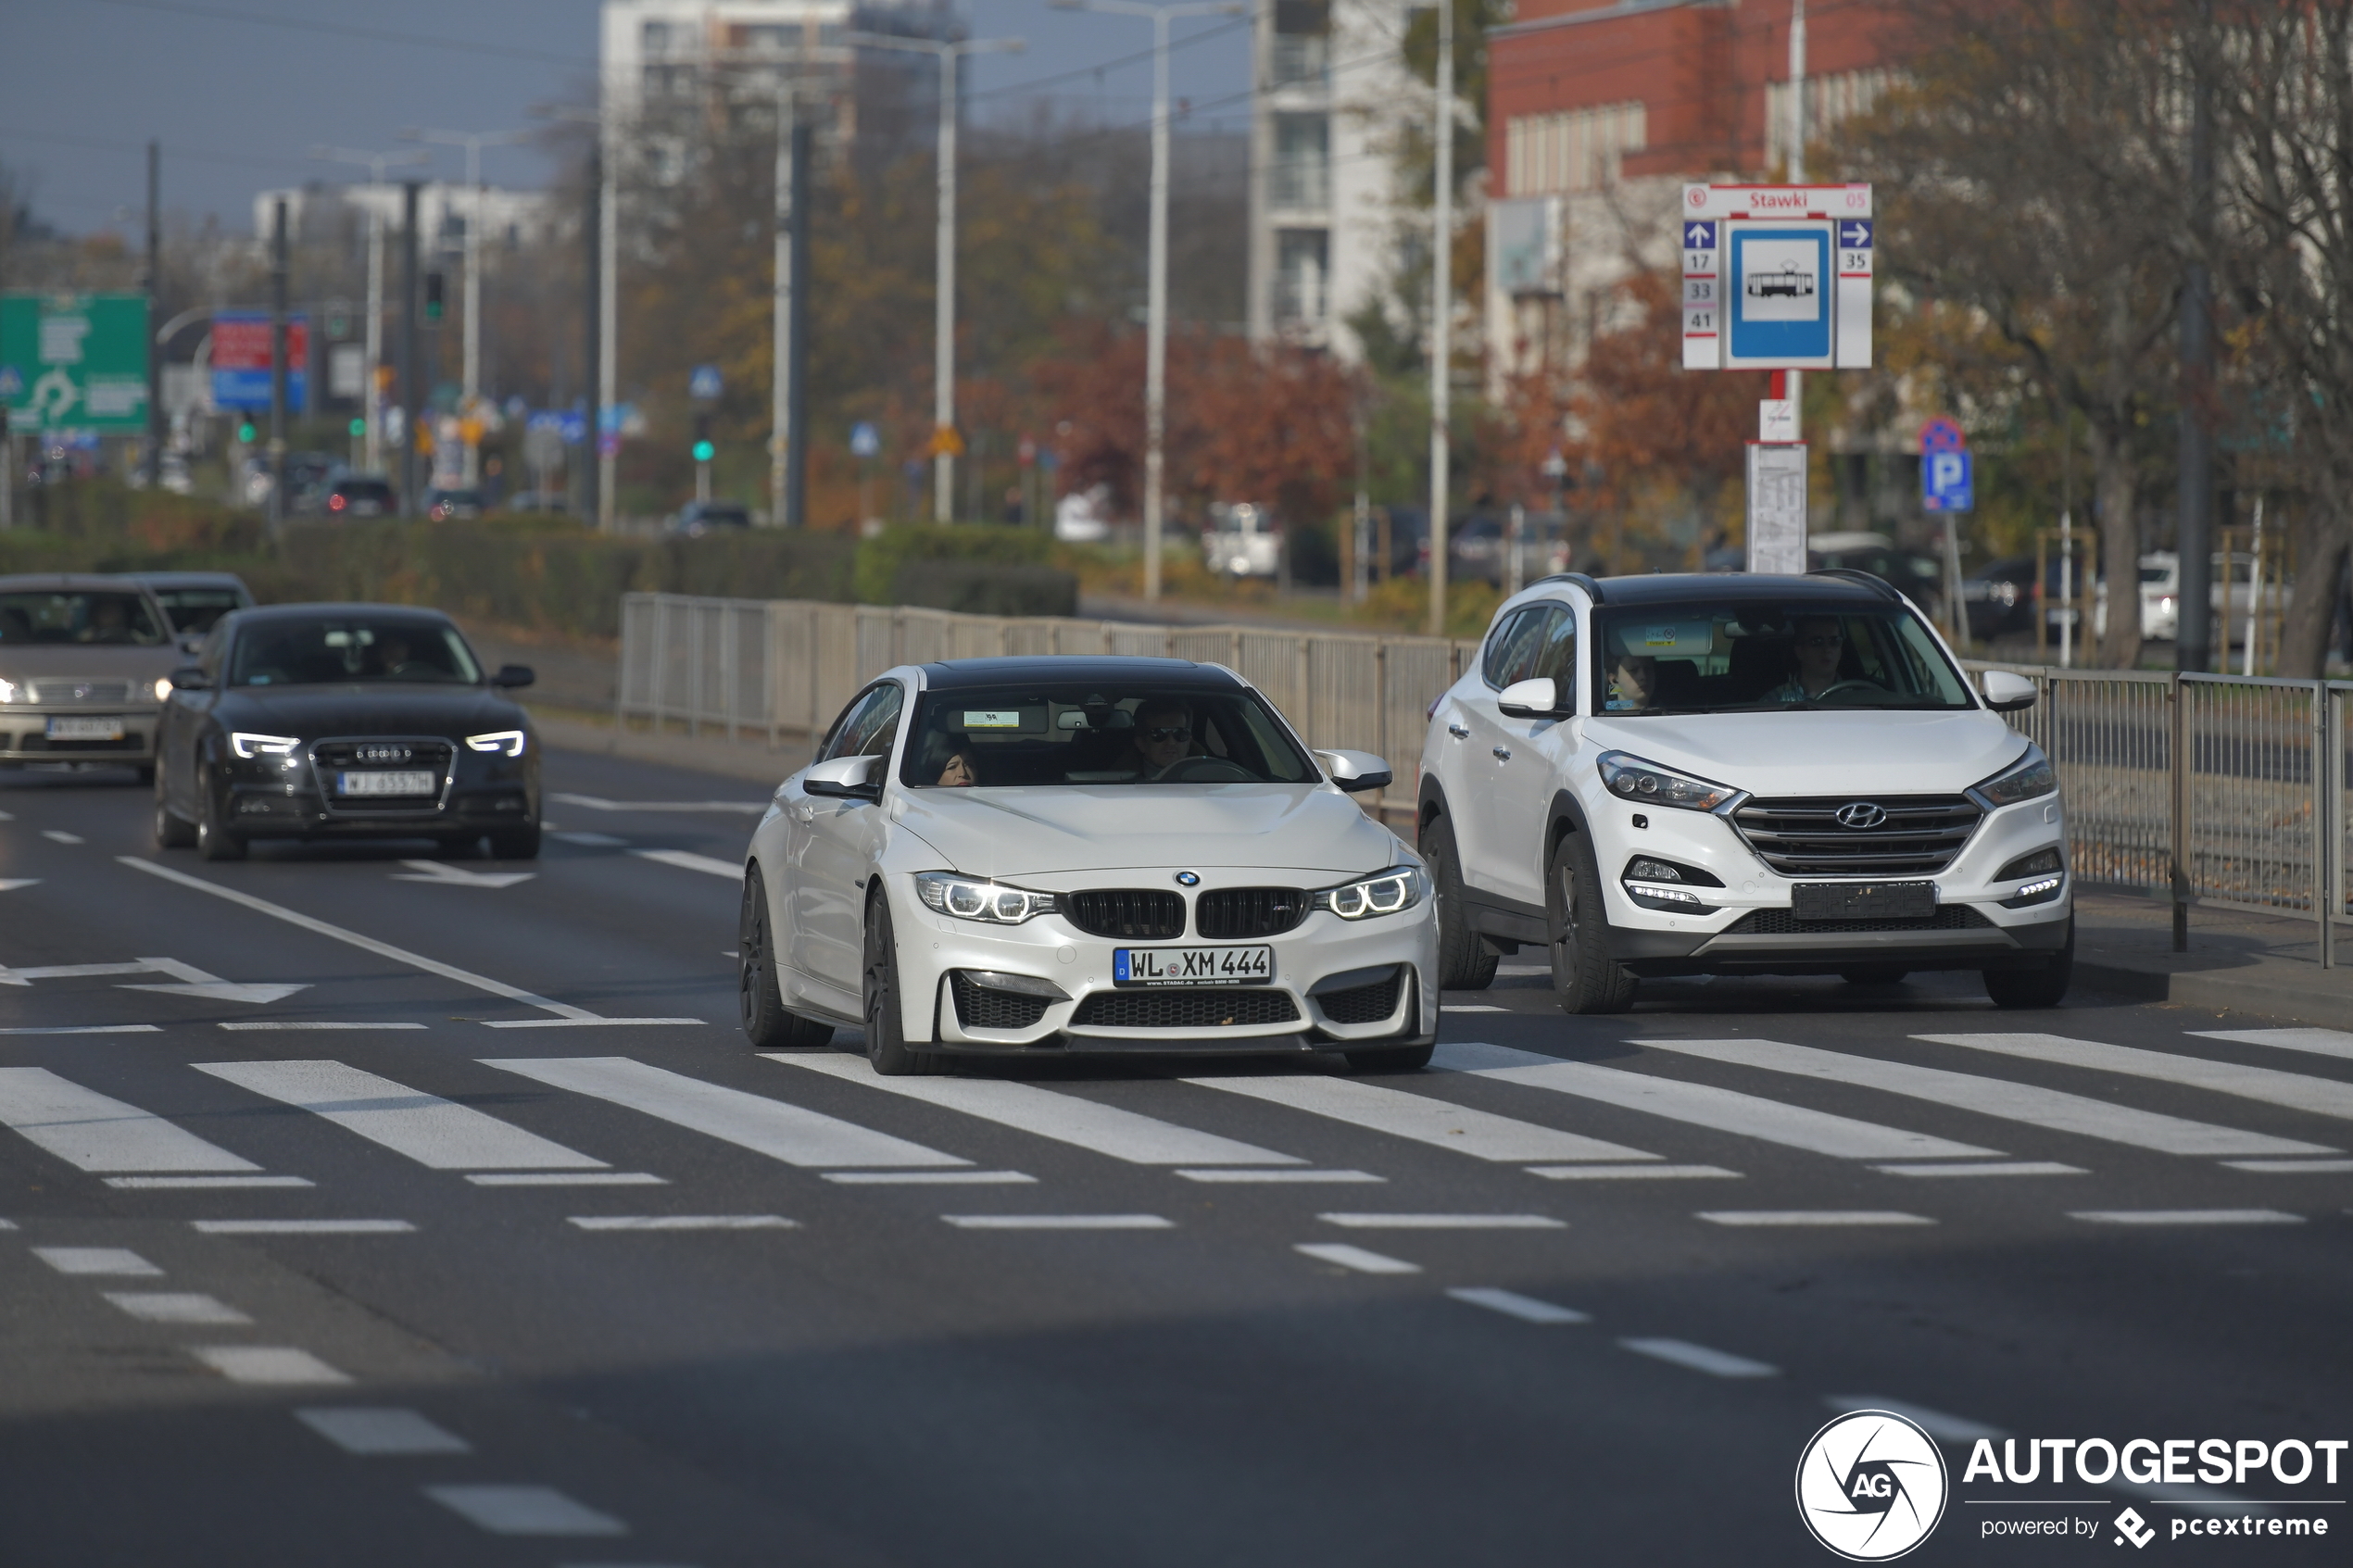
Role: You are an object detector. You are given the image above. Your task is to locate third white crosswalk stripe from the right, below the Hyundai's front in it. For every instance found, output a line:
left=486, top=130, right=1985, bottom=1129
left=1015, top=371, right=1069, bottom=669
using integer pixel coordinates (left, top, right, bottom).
left=1656, top=1039, right=2330, bottom=1159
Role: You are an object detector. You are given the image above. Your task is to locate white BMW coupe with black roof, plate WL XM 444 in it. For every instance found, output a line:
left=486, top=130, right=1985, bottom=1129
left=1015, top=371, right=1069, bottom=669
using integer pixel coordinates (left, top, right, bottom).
left=739, top=659, right=1438, bottom=1074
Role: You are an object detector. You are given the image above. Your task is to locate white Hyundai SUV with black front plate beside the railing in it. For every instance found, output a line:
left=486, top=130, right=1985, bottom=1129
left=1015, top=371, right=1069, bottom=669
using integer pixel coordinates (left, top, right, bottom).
left=1419, top=571, right=2075, bottom=1013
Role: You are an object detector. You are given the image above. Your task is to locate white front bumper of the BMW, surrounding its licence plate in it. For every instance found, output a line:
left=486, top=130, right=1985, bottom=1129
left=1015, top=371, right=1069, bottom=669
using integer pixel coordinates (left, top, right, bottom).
left=887, top=870, right=1438, bottom=1053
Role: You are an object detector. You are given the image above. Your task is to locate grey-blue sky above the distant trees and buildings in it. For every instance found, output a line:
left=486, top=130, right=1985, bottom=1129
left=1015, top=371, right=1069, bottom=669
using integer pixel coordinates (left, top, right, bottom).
left=0, top=0, right=1250, bottom=235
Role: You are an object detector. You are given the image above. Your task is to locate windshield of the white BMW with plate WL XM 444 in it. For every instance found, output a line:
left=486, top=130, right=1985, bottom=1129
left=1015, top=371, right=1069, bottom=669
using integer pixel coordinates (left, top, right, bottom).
left=899, top=682, right=1320, bottom=790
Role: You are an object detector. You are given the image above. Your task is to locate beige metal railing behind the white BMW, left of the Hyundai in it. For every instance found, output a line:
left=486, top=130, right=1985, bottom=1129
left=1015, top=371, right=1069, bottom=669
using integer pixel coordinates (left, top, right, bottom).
left=616, top=593, right=1480, bottom=821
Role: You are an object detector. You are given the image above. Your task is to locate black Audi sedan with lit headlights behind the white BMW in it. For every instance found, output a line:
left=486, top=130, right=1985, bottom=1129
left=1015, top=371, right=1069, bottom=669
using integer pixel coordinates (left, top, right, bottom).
left=156, top=604, right=539, bottom=860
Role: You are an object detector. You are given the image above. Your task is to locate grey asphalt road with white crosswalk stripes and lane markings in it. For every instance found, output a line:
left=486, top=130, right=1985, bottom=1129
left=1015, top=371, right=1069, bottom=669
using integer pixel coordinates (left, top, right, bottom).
left=0, top=755, right=2353, bottom=1568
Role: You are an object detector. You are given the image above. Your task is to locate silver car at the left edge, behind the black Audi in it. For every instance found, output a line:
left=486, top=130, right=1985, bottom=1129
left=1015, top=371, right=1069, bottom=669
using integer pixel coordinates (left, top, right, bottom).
left=0, top=573, right=182, bottom=781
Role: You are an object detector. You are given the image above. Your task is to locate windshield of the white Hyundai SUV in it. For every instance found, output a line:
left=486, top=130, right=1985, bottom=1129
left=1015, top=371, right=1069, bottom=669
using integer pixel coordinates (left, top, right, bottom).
left=1593, top=599, right=1977, bottom=715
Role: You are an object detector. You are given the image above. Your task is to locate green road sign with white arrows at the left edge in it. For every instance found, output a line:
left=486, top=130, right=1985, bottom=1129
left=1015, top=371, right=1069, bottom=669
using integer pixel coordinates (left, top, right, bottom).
left=0, top=294, right=148, bottom=430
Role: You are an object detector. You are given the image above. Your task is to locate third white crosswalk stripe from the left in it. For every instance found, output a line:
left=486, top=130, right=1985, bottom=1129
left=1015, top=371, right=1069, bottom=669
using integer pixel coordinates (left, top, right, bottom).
left=483, top=1056, right=972, bottom=1169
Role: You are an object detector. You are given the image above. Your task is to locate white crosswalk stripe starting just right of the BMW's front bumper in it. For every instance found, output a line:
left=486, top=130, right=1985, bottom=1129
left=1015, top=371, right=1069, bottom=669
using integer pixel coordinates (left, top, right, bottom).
left=1438, top=1041, right=2000, bottom=1159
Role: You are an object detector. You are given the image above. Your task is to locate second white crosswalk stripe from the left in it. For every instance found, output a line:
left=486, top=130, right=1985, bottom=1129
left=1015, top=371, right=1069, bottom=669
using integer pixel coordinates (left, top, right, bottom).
left=191, top=1060, right=605, bottom=1171
